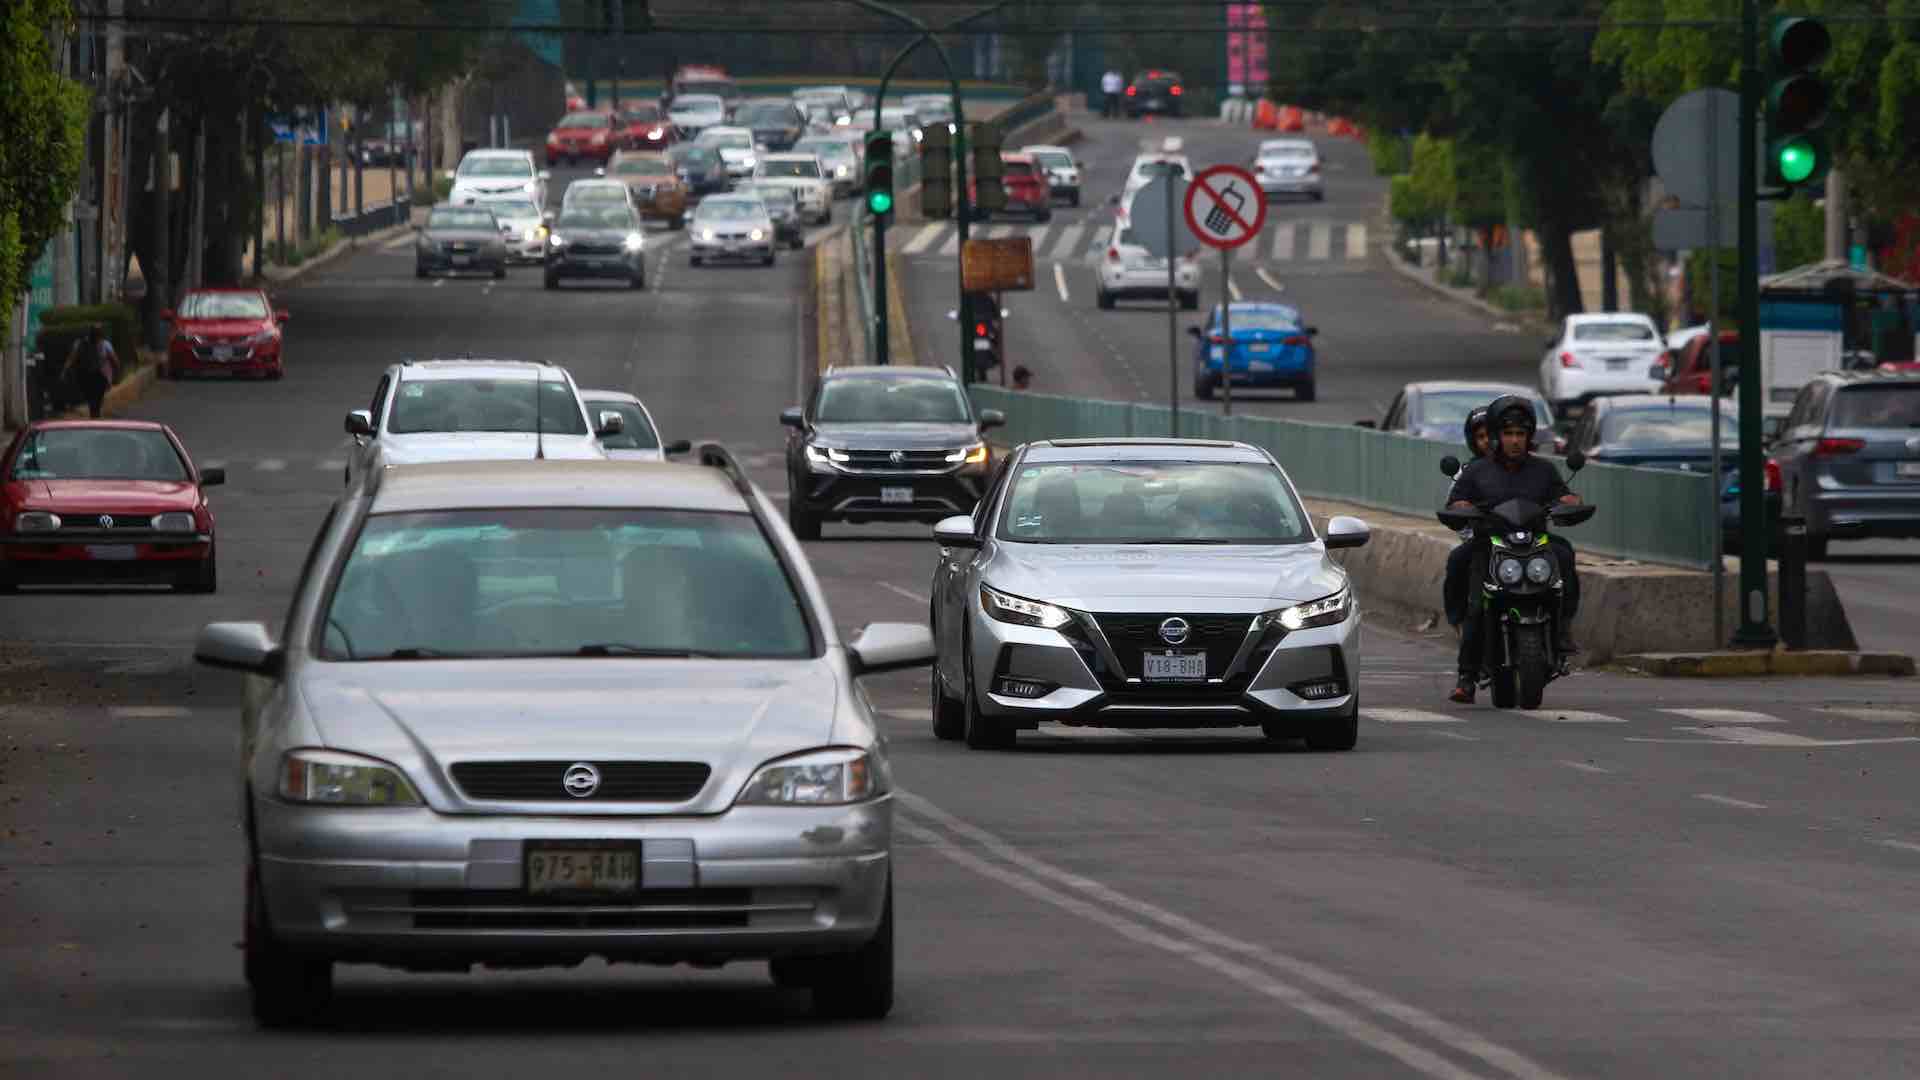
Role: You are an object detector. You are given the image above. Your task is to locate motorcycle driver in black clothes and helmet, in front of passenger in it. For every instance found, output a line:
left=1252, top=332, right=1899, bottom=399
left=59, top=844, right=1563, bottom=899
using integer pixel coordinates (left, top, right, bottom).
left=1448, top=394, right=1580, bottom=703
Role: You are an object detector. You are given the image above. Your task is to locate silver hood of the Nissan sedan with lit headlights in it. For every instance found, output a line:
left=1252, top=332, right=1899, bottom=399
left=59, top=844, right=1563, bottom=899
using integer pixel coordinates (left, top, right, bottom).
left=981, top=542, right=1346, bottom=613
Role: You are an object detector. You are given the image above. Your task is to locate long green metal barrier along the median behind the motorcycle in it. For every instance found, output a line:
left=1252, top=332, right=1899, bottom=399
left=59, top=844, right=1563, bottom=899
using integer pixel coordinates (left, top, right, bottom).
left=972, top=382, right=1720, bottom=569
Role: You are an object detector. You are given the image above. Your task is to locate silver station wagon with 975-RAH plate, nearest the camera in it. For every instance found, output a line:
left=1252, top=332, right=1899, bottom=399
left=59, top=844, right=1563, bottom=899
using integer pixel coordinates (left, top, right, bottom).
left=196, top=444, right=933, bottom=1026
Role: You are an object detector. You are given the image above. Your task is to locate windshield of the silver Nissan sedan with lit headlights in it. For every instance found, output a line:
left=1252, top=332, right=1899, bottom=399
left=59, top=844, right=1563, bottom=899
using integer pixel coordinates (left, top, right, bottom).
left=1000, top=461, right=1311, bottom=544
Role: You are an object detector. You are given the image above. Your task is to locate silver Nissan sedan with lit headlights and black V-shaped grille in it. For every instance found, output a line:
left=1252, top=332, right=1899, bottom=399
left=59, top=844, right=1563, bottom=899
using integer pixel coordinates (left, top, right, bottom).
left=931, top=438, right=1369, bottom=749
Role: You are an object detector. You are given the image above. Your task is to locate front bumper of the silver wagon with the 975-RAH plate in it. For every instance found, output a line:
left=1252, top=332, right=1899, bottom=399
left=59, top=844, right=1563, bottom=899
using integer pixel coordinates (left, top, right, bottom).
left=253, top=798, right=893, bottom=967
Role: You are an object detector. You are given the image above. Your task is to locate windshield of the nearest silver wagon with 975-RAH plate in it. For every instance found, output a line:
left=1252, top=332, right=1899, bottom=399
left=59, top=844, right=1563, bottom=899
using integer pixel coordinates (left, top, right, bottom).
left=321, top=509, right=814, bottom=661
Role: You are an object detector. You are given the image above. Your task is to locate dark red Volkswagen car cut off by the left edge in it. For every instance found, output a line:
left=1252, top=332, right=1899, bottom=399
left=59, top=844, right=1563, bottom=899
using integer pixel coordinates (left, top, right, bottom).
left=0, top=421, right=227, bottom=592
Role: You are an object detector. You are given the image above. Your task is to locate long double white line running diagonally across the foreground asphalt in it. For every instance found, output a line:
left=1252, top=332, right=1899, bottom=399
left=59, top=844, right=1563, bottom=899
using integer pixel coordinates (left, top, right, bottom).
left=897, top=792, right=1557, bottom=1080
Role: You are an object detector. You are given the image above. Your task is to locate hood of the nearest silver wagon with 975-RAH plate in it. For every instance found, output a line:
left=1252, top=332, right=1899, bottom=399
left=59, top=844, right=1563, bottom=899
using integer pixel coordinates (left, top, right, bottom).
left=300, top=657, right=837, bottom=813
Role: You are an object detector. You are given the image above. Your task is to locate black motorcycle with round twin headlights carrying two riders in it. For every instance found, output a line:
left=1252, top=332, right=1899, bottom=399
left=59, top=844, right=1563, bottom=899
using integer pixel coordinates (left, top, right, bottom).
left=1438, top=450, right=1599, bottom=709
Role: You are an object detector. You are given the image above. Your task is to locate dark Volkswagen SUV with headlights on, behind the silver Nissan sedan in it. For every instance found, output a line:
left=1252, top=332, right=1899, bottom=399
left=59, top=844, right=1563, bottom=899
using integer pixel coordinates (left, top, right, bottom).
left=780, top=367, right=1006, bottom=540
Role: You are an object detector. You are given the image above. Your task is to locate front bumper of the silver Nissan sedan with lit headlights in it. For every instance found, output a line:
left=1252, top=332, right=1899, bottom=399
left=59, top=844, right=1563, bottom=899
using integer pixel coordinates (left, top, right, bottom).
left=968, top=596, right=1361, bottom=728
